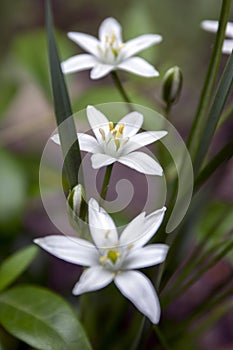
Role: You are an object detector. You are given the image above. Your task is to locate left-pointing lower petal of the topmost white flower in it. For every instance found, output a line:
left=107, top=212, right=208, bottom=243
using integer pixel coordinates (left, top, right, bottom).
left=61, top=54, right=96, bottom=74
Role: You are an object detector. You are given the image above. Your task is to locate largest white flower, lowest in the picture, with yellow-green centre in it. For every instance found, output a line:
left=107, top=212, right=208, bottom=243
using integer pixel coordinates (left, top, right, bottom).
left=34, top=199, right=168, bottom=324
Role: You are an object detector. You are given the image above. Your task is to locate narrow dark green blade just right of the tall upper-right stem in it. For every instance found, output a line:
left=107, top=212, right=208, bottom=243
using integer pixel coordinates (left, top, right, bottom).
left=194, top=54, right=233, bottom=173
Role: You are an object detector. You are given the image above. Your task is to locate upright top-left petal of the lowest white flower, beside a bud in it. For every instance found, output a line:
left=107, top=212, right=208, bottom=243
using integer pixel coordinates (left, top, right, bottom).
left=88, top=198, right=118, bottom=248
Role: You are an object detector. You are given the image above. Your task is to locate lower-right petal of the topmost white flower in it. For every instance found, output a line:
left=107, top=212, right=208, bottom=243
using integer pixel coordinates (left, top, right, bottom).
left=117, top=57, right=159, bottom=78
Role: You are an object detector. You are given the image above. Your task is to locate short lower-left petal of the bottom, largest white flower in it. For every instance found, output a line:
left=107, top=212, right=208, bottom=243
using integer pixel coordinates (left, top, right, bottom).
left=72, top=266, right=113, bottom=295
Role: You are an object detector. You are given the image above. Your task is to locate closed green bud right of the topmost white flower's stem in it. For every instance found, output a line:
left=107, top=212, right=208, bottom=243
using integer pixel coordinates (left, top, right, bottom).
left=162, top=66, right=183, bottom=106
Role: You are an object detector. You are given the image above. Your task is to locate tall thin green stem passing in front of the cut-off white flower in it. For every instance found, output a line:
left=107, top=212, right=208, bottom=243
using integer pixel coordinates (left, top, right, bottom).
left=187, top=0, right=231, bottom=159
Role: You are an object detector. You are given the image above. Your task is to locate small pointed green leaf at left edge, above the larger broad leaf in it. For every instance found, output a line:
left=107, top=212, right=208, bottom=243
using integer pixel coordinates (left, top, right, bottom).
left=0, top=245, right=38, bottom=291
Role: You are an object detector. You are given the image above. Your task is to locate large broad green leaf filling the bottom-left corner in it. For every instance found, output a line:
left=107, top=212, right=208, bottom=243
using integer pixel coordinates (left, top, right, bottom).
left=0, top=285, right=91, bottom=350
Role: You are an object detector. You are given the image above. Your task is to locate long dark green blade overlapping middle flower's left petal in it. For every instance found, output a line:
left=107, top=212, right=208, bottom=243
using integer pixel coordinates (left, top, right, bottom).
left=46, top=0, right=81, bottom=189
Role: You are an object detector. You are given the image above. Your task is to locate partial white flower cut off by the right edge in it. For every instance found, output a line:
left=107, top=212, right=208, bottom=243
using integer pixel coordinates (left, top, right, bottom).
left=201, top=20, right=233, bottom=55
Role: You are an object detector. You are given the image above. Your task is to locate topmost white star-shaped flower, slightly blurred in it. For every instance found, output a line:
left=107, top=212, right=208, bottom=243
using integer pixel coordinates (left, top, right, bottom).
left=62, top=17, right=162, bottom=79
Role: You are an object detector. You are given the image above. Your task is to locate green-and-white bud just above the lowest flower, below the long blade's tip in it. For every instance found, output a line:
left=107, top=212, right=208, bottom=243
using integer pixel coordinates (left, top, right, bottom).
left=67, top=184, right=87, bottom=226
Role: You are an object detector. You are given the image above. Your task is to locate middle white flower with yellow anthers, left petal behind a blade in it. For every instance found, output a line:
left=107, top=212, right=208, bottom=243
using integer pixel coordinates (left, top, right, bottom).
left=52, top=106, right=167, bottom=176
